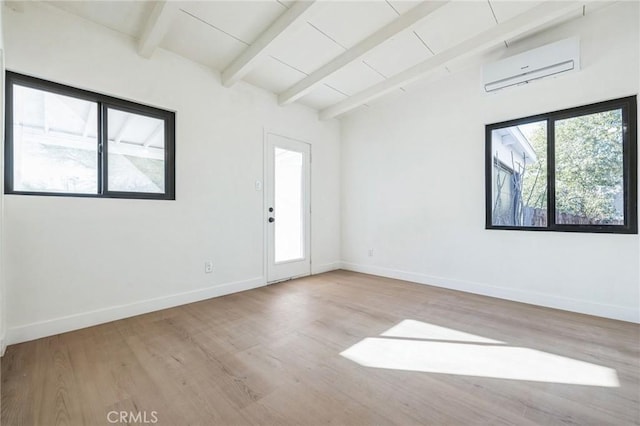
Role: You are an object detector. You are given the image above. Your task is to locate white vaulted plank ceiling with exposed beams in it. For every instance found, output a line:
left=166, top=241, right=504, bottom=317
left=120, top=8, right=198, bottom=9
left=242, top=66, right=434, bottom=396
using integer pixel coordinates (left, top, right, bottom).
left=46, top=0, right=596, bottom=118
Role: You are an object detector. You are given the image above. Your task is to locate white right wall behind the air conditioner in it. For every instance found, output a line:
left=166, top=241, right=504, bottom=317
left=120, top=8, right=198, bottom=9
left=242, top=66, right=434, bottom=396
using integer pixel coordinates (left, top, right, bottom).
left=342, top=2, right=640, bottom=322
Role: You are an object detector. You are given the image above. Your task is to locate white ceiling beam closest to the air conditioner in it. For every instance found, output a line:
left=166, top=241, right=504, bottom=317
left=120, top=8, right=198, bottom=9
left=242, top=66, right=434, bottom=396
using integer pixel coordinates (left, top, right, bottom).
left=320, top=0, right=589, bottom=120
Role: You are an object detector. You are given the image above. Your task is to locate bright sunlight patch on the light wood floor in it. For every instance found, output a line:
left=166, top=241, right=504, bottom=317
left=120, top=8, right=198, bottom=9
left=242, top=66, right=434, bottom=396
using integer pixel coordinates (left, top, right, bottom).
left=340, top=320, right=620, bottom=387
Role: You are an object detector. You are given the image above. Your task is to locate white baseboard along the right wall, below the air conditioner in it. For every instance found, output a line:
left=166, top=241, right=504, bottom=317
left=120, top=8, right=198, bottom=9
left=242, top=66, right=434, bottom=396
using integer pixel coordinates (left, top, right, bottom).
left=342, top=262, right=640, bottom=323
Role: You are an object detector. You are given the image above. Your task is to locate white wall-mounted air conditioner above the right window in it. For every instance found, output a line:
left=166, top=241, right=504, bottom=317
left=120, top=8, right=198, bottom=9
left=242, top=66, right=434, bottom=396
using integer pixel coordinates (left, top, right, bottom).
left=482, top=37, right=580, bottom=92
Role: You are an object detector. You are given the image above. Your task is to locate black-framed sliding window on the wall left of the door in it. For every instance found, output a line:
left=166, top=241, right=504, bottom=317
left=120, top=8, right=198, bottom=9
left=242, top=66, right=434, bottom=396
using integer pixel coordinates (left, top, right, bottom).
left=5, top=71, right=175, bottom=200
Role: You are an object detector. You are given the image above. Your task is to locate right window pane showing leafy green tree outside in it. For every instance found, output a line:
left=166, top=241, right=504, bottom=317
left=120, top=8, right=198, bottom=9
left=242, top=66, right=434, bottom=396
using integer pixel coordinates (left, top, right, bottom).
left=555, top=109, right=624, bottom=225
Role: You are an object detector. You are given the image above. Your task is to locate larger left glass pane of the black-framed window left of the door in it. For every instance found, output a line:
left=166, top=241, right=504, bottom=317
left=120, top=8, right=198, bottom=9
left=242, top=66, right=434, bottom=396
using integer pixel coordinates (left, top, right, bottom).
left=12, top=85, right=98, bottom=194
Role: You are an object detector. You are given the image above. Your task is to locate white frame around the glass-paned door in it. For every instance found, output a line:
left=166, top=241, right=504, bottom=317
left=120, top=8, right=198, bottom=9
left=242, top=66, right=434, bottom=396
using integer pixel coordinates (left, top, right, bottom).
left=262, top=127, right=313, bottom=285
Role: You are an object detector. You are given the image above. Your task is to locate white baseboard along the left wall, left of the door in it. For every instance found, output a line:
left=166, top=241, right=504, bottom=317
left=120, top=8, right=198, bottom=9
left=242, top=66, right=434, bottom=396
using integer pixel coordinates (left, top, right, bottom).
left=3, top=277, right=266, bottom=346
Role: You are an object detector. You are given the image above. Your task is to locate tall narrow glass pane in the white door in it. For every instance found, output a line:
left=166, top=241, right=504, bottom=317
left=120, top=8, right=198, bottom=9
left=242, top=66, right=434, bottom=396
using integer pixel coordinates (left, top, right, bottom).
left=274, top=148, right=304, bottom=262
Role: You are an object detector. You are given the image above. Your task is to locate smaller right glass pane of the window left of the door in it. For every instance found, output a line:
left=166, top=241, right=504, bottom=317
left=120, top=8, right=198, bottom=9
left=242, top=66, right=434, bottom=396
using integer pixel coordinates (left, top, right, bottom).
left=107, top=108, right=165, bottom=193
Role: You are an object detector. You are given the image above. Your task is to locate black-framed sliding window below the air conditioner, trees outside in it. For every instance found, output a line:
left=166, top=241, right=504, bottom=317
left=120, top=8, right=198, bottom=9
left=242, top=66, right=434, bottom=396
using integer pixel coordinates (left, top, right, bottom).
left=485, top=96, right=638, bottom=234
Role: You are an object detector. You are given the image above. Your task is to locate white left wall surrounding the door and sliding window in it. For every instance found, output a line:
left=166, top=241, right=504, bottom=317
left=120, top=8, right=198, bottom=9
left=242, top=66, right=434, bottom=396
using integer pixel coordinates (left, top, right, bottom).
left=4, top=3, right=340, bottom=343
